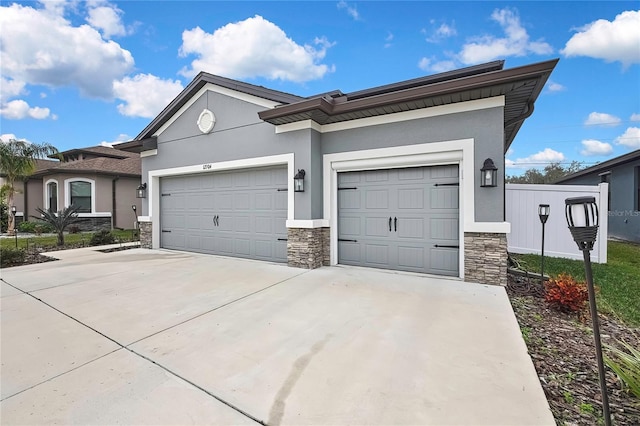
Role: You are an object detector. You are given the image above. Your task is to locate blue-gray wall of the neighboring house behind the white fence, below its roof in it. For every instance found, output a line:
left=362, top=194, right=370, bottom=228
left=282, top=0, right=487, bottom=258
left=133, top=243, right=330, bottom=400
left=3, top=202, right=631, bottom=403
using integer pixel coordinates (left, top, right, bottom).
left=561, top=160, right=640, bottom=242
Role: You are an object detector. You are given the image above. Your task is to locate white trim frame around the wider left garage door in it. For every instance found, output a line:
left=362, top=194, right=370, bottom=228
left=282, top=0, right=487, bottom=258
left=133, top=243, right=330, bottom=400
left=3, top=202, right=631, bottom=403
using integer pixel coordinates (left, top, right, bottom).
left=146, top=153, right=295, bottom=248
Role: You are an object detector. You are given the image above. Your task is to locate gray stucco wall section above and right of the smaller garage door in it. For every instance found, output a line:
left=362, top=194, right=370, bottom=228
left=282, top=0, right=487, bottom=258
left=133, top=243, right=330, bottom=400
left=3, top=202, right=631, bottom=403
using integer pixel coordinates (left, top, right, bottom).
left=322, top=108, right=504, bottom=222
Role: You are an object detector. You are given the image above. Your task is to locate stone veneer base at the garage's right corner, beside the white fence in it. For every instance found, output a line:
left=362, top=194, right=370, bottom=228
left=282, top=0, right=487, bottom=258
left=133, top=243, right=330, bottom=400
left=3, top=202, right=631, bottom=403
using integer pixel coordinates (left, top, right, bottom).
left=464, top=232, right=507, bottom=286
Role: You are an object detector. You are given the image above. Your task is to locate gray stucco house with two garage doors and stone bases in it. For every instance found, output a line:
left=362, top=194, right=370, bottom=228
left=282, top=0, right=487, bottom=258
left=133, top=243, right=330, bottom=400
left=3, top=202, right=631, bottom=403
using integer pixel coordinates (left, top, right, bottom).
left=120, top=60, right=557, bottom=284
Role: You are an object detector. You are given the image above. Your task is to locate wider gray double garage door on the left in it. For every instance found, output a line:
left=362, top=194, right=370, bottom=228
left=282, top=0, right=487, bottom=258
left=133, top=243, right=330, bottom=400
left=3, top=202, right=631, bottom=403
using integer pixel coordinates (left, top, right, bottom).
left=160, top=167, right=287, bottom=262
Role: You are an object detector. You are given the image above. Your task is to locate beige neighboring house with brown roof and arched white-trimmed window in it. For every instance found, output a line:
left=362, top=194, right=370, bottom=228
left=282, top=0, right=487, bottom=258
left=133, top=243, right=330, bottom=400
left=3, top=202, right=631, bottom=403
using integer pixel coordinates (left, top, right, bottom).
left=4, top=146, right=141, bottom=230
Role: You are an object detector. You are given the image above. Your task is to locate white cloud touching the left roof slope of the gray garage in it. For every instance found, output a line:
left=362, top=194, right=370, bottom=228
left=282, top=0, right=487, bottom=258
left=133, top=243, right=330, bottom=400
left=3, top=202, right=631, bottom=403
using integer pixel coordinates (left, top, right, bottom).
left=113, top=74, right=182, bottom=118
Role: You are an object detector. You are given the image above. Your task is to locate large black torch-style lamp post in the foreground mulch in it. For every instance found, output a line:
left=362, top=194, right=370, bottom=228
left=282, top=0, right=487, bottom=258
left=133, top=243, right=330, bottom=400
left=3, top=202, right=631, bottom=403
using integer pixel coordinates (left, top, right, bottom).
left=565, top=197, right=611, bottom=426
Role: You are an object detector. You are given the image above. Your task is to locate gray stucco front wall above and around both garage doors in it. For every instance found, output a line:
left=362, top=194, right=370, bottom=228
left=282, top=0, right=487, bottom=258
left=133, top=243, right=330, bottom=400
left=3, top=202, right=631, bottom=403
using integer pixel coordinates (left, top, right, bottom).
left=142, top=91, right=504, bottom=222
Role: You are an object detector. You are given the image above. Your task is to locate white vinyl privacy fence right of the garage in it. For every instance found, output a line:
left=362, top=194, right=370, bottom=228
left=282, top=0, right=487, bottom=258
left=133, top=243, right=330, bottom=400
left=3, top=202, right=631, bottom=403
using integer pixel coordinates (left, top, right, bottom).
left=505, top=183, right=609, bottom=263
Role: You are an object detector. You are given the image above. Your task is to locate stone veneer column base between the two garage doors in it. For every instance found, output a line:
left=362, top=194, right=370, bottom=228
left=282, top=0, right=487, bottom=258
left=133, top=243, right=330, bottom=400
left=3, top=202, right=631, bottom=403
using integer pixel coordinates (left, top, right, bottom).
left=287, top=228, right=329, bottom=269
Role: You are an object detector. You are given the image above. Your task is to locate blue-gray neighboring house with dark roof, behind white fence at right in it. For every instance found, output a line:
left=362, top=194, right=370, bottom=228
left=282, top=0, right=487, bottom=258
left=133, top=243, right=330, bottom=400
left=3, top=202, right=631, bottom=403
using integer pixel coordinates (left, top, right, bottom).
left=556, top=150, right=640, bottom=243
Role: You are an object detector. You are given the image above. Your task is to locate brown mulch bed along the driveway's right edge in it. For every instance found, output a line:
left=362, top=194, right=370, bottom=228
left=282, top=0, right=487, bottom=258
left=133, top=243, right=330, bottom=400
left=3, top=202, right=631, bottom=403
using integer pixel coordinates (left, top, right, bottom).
left=507, top=275, right=640, bottom=426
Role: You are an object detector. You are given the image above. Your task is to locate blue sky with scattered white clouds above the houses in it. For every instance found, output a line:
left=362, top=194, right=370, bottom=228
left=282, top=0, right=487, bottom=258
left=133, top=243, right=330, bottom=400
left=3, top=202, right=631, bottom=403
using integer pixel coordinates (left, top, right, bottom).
left=0, top=1, right=640, bottom=174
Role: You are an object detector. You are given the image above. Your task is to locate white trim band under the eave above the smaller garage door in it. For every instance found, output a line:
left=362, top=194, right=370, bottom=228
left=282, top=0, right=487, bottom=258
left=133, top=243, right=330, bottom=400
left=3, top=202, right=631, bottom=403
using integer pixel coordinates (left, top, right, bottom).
left=276, top=95, right=505, bottom=133
